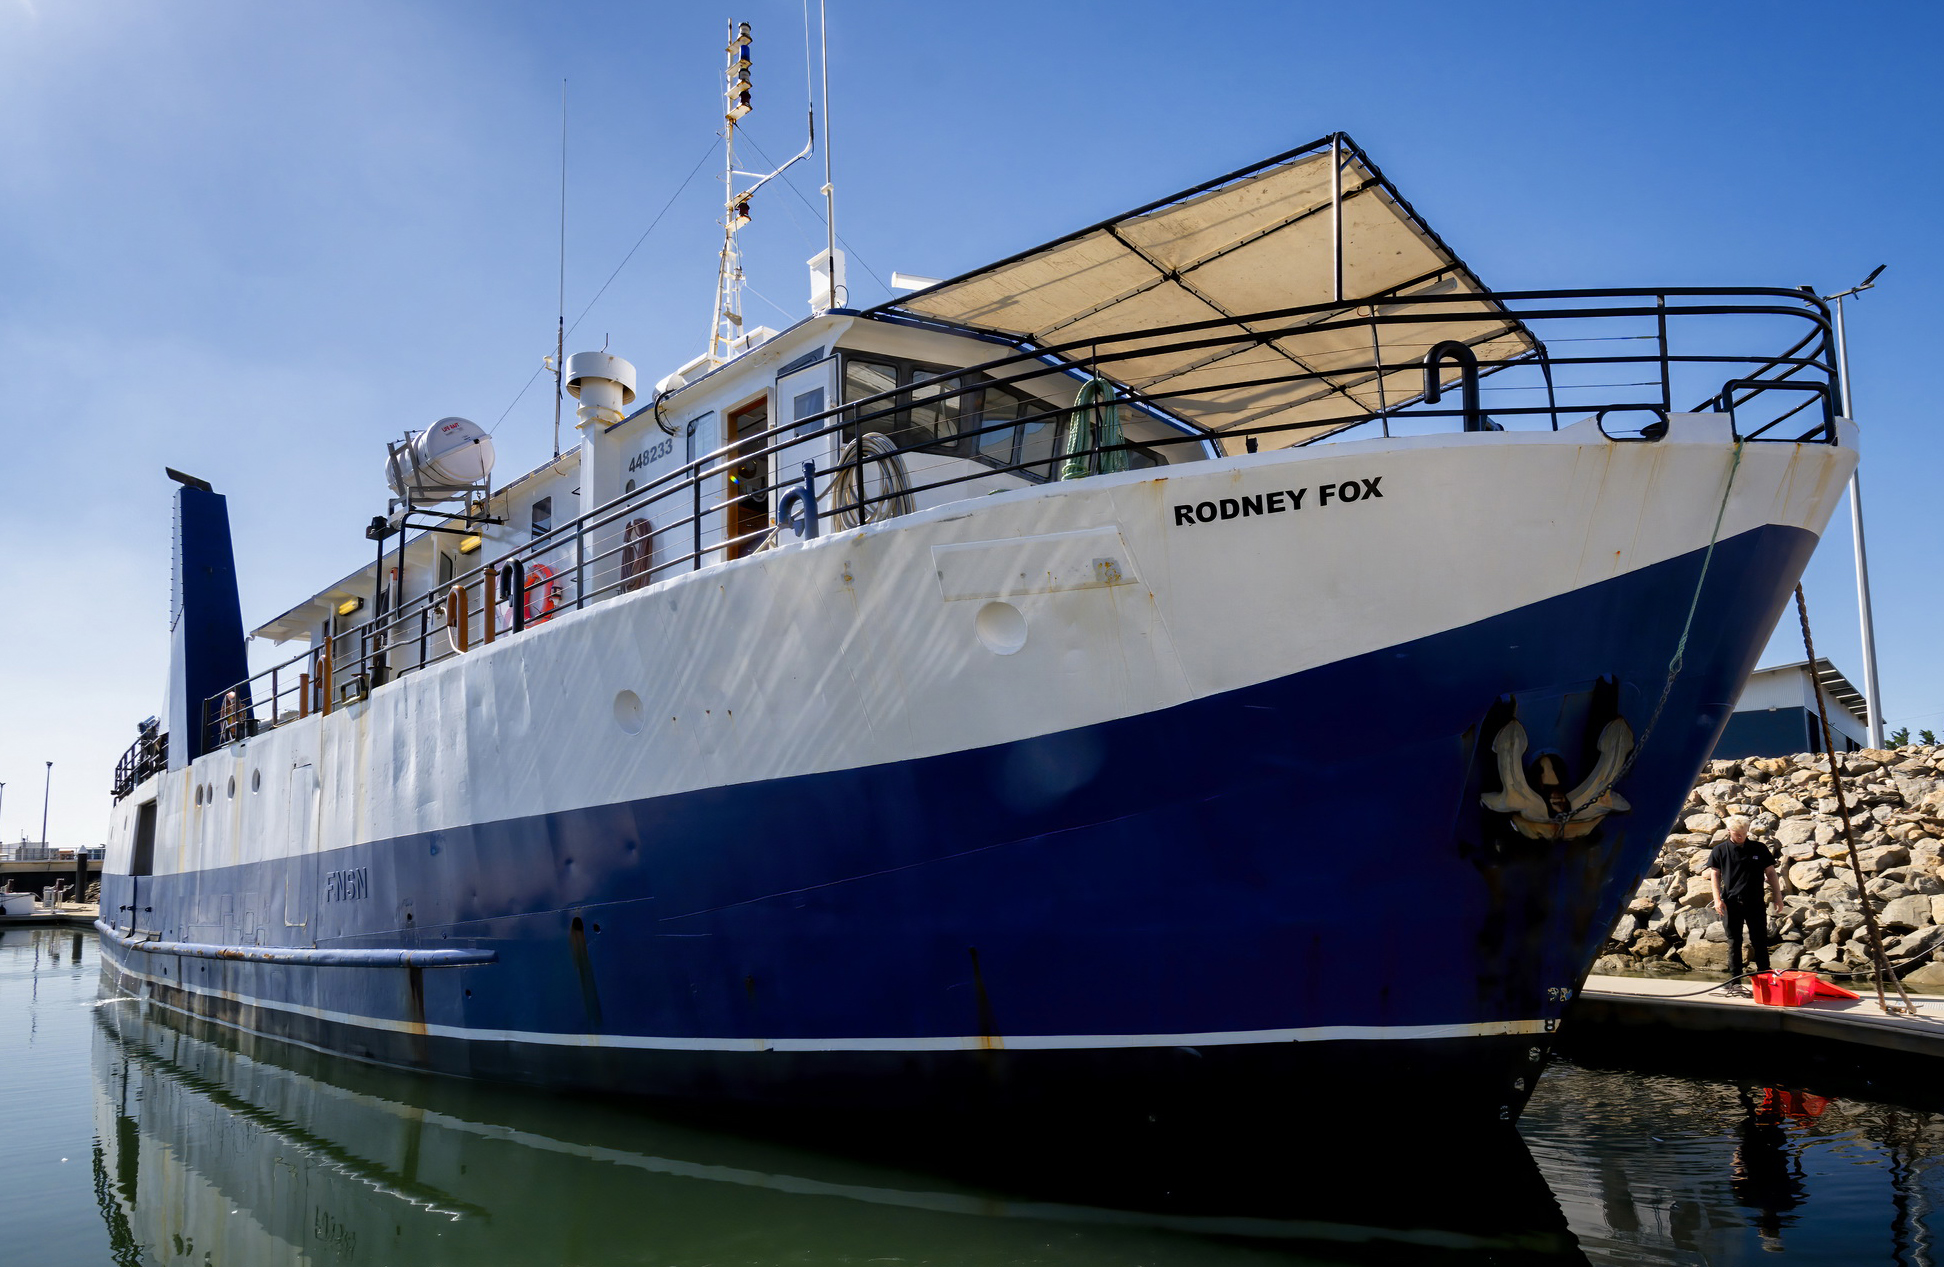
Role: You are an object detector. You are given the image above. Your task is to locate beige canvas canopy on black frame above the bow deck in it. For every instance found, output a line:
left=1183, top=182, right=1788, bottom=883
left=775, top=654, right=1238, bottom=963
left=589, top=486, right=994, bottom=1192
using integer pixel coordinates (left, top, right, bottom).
left=873, top=134, right=1538, bottom=449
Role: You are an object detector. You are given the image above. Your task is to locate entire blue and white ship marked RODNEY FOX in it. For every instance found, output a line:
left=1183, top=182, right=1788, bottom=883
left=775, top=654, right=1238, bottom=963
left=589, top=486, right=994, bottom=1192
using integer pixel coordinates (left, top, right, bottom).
left=97, top=96, right=1857, bottom=1129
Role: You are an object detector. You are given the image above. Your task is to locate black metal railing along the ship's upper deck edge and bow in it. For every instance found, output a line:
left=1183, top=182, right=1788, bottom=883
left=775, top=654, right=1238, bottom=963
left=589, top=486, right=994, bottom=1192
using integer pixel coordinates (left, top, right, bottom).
left=197, top=288, right=1837, bottom=753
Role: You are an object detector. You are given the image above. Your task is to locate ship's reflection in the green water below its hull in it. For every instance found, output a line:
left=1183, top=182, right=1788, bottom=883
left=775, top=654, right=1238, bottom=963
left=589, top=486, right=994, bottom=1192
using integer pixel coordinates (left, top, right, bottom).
left=93, top=999, right=1584, bottom=1267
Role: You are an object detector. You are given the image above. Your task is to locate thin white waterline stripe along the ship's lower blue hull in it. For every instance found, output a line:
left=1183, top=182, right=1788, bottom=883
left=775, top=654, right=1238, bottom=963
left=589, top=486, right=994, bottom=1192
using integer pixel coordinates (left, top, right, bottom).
left=106, top=948, right=1557, bottom=1051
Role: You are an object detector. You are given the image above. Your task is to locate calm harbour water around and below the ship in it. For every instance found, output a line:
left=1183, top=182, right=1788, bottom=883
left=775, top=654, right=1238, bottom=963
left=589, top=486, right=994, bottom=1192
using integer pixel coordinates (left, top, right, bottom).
left=0, top=929, right=1944, bottom=1267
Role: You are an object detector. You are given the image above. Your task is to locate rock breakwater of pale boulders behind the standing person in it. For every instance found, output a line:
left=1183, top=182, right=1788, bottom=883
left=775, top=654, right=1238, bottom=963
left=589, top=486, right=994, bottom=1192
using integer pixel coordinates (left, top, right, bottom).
left=1594, top=746, right=1944, bottom=989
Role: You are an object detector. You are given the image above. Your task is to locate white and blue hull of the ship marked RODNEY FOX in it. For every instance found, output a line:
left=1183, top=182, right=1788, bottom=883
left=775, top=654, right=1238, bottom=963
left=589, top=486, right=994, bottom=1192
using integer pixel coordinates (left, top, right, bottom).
left=103, top=416, right=1855, bottom=1117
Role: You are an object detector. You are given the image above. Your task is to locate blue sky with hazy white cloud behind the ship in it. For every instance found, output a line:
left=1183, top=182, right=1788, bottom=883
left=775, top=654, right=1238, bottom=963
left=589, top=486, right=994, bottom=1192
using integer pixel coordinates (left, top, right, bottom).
left=0, top=0, right=1944, bottom=843
